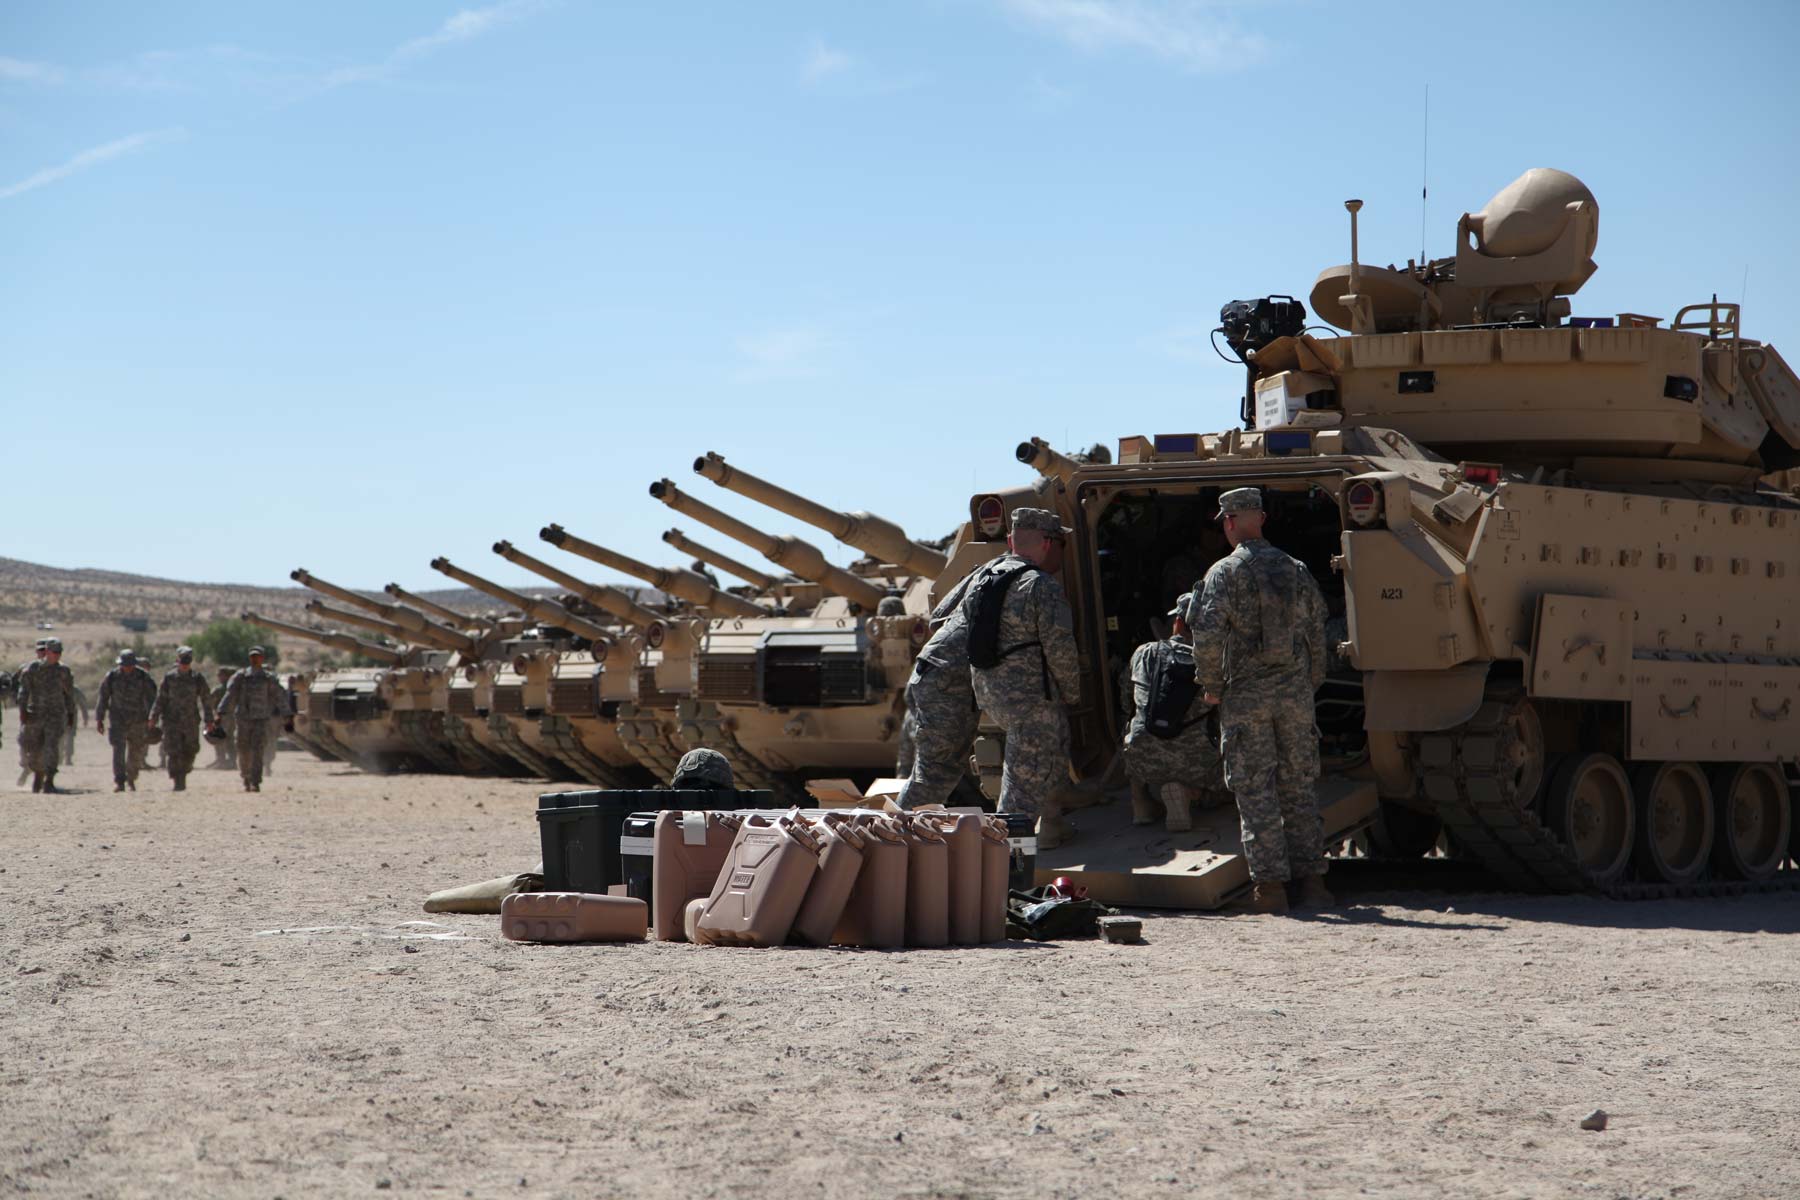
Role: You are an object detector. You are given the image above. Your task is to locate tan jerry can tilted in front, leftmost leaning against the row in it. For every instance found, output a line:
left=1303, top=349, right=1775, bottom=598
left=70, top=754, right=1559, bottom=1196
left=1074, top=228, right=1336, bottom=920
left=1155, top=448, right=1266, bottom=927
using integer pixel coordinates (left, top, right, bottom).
left=695, top=811, right=821, bottom=946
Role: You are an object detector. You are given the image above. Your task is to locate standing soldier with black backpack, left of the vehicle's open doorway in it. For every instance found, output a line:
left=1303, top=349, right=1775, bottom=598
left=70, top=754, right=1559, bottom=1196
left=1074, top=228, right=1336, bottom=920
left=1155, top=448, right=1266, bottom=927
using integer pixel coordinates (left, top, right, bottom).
left=964, top=509, right=1082, bottom=849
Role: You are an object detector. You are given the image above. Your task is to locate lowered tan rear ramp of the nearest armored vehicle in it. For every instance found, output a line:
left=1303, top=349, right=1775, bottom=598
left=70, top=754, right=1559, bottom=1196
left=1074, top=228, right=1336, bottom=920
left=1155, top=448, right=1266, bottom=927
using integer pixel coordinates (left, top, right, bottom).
left=1037, top=777, right=1377, bottom=910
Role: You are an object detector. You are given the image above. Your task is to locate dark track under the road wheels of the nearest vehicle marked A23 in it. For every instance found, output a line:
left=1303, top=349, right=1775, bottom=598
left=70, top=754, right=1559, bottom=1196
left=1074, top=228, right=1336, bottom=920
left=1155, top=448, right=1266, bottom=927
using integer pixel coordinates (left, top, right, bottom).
left=1418, top=694, right=1800, bottom=900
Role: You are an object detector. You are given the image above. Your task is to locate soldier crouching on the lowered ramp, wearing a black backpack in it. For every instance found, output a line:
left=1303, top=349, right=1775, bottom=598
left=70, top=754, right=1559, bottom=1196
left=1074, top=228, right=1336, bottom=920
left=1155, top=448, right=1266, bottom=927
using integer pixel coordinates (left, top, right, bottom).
left=1123, top=594, right=1224, bottom=833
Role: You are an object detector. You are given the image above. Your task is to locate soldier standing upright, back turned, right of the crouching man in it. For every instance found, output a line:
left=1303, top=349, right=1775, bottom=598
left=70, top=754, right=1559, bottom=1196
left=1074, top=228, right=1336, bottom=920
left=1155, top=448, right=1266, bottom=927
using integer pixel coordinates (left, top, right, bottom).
left=1186, top=488, right=1334, bottom=912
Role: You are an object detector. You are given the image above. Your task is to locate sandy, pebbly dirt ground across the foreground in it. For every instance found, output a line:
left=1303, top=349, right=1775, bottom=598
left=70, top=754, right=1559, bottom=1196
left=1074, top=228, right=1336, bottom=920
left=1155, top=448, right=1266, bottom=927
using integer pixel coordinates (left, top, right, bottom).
left=0, top=720, right=1800, bottom=1200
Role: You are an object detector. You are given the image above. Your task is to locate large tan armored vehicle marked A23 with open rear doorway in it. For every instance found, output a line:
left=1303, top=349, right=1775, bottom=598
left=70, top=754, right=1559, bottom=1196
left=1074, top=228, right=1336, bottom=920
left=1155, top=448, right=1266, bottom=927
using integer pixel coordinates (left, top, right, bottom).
left=972, top=169, right=1800, bottom=894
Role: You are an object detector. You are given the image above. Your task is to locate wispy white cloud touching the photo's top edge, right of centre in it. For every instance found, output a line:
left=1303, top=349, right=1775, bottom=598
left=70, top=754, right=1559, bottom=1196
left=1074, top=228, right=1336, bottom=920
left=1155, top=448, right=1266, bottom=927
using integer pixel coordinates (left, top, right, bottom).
left=999, top=0, right=1267, bottom=70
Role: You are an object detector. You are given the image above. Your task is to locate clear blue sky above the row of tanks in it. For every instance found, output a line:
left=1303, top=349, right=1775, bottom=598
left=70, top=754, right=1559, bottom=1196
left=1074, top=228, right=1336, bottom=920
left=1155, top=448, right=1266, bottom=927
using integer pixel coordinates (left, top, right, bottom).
left=10, top=0, right=1800, bottom=587
